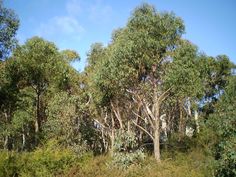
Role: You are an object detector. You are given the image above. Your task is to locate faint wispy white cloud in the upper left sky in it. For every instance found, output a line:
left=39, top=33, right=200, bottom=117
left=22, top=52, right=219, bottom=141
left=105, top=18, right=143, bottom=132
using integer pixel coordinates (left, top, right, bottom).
left=33, top=0, right=113, bottom=48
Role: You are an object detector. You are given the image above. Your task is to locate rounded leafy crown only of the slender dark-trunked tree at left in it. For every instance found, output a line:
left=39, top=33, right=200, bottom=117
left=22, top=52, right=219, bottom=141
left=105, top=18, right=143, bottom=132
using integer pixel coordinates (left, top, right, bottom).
left=13, top=37, right=59, bottom=87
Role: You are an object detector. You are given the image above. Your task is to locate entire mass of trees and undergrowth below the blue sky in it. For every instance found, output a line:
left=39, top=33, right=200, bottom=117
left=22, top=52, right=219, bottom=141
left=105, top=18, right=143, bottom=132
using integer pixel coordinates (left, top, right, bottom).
left=0, top=1, right=236, bottom=177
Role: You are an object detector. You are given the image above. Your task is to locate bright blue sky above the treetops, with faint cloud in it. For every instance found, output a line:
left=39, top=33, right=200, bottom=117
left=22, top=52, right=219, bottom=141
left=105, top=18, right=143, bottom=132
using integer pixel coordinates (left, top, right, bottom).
left=3, top=0, right=236, bottom=71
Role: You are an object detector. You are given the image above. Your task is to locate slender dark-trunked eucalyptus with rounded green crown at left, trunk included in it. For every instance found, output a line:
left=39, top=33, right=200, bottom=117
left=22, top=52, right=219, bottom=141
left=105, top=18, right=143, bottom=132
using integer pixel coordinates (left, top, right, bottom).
left=13, top=37, right=59, bottom=136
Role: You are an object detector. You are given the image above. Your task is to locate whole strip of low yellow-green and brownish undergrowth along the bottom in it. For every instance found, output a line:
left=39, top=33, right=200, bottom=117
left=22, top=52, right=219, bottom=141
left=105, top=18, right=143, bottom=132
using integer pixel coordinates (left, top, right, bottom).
left=0, top=142, right=213, bottom=177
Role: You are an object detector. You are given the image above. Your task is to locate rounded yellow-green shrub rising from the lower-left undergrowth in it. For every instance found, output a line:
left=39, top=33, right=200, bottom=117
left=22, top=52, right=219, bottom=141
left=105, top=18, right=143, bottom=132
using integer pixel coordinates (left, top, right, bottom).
left=21, top=141, right=76, bottom=176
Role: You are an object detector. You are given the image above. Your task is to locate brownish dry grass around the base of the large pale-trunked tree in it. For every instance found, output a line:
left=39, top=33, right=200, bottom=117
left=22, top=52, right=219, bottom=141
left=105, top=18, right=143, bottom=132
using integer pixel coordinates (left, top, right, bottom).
left=63, top=151, right=211, bottom=177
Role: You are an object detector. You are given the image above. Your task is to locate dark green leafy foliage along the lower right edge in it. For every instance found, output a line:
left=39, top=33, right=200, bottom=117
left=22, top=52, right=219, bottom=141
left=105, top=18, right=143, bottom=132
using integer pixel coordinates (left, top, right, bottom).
left=203, top=76, right=236, bottom=176
